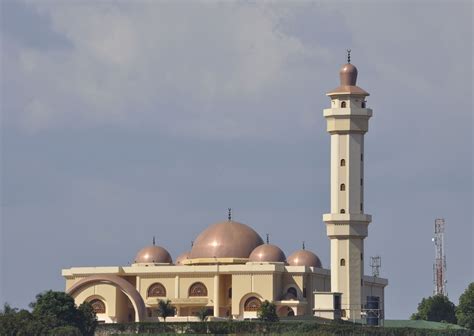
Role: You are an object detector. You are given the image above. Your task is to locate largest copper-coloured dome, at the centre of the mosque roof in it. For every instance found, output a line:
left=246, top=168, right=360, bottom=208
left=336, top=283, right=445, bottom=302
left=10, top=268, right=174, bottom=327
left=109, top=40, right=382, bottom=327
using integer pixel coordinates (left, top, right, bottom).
left=189, top=220, right=263, bottom=259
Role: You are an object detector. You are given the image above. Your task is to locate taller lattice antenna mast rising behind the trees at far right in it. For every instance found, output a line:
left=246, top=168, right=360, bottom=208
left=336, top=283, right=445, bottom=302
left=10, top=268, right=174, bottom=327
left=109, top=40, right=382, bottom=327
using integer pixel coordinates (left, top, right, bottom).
left=432, top=218, right=448, bottom=295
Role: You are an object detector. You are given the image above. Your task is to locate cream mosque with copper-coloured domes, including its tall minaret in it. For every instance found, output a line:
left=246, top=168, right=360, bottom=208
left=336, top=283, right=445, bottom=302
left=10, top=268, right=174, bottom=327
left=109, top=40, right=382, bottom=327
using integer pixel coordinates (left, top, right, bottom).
left=62, top=57, right=388, bottom=323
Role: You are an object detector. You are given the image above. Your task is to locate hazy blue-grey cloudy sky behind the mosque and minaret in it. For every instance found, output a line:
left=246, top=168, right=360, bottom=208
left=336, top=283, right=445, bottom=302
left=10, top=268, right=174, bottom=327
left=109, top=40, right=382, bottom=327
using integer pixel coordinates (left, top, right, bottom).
left=0, top=0, right=474, bottom=319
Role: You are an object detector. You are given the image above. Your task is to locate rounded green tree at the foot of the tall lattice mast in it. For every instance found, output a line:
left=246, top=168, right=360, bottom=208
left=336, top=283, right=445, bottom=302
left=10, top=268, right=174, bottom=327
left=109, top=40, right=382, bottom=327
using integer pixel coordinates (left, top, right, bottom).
left=411, top=295, right=457, bottom=323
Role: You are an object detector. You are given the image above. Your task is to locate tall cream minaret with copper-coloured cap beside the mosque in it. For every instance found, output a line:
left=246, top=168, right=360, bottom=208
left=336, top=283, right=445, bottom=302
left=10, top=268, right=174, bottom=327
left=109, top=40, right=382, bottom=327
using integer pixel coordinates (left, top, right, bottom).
left=323, top=50, right=372, bottom=319
